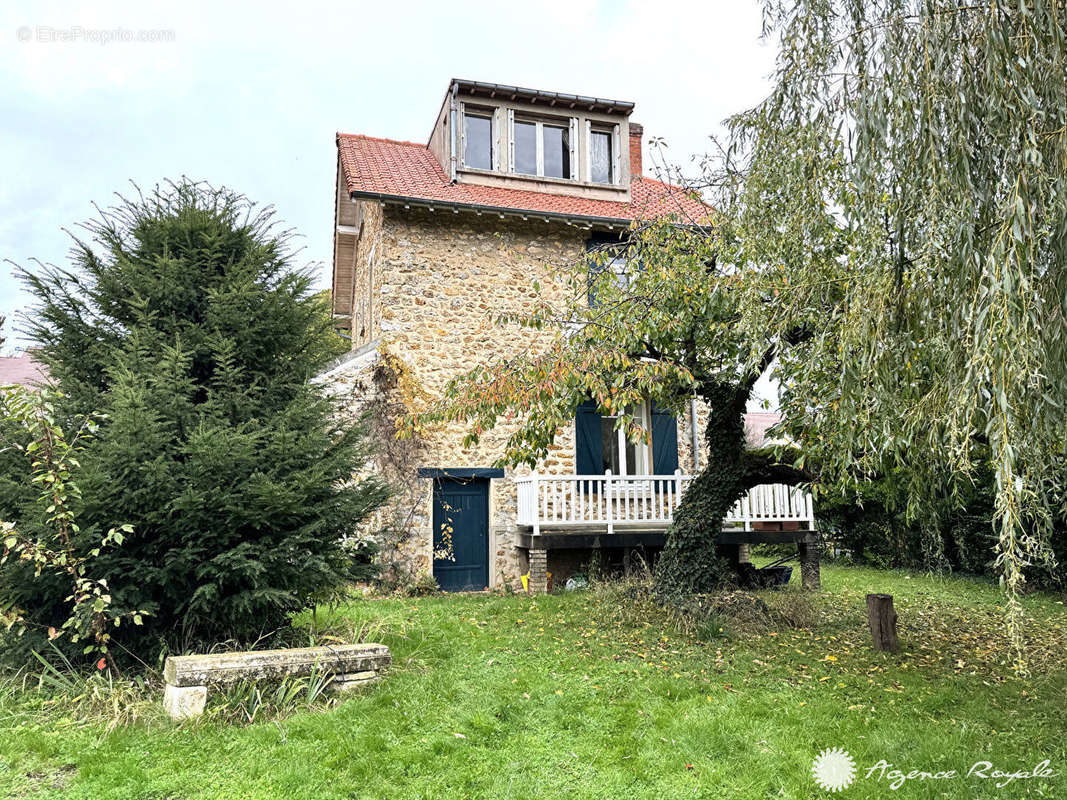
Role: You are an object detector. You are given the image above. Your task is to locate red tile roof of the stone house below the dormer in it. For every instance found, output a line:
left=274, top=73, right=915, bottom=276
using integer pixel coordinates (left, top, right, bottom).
left=337, top=133, right=711, bottom=223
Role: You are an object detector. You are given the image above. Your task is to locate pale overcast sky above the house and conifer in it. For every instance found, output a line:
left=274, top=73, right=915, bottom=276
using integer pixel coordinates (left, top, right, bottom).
left=0, top=0, right=774, bottom=352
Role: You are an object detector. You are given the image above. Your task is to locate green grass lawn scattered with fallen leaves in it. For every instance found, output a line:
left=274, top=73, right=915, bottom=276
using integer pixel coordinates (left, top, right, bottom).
left=0, top=567, right=1067, bottom=800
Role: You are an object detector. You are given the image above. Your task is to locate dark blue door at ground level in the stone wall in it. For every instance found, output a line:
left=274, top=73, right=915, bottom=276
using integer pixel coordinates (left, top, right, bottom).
left=433, top=478, right=489, bottom=592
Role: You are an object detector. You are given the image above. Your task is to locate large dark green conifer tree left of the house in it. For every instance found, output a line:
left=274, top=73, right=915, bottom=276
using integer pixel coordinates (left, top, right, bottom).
left=0, top=180, right=385, bottom=647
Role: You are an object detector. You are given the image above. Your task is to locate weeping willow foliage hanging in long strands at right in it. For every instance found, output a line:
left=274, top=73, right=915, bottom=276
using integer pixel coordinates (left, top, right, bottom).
left=713, top=0, right=1067, bottom=652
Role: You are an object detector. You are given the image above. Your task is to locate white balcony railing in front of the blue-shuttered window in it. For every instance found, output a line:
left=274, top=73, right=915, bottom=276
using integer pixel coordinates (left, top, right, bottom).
left=515, top=471, right=815, bottom=533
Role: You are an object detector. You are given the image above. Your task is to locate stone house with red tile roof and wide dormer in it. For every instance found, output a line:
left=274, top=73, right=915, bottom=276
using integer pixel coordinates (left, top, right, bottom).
left=320, top=80, right=811, bottom=591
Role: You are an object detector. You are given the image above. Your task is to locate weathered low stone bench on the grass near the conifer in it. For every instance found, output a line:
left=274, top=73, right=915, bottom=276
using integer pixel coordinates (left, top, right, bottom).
left=163, top=644, right=393, bottom=720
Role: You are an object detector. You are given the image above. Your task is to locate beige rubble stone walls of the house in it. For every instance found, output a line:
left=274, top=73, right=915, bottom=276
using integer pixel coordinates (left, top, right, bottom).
left=327, top=204, right=703, bottom=588
